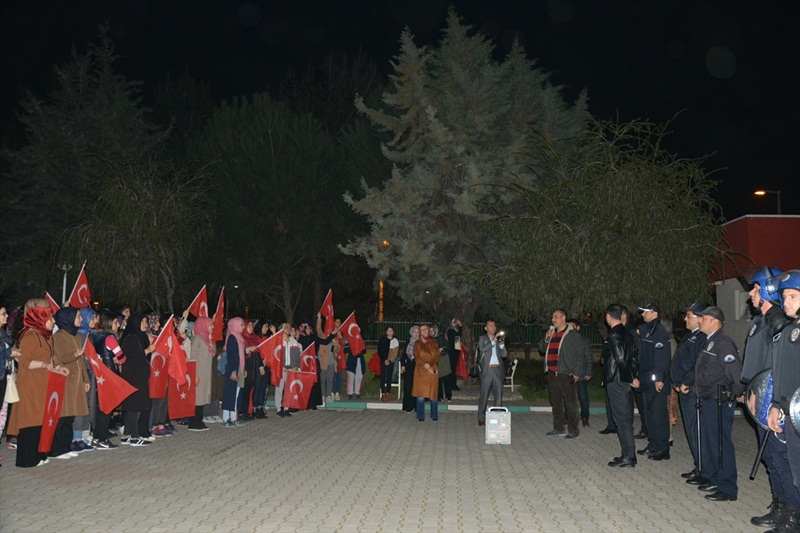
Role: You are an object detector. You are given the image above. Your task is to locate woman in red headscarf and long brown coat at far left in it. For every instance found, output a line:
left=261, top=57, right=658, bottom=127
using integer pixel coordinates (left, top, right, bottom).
left=8, top=298, right=69, bottom=468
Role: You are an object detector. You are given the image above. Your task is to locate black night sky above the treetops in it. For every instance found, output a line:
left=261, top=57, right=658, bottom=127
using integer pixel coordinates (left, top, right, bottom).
left=0, top=0, right=800, bottom=219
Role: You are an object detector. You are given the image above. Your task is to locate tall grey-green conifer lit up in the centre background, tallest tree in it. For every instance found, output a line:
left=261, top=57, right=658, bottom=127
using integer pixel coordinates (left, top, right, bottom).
left=342, top=9, right=587, bottom=338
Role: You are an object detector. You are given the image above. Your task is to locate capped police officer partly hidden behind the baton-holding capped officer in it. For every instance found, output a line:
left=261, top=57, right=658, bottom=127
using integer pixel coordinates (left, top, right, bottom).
left=670, top=303, right=706, bottom=479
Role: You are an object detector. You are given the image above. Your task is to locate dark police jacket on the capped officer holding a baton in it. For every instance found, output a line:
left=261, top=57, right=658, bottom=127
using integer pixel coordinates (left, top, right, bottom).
left=695, top=330, right=745, bottom=399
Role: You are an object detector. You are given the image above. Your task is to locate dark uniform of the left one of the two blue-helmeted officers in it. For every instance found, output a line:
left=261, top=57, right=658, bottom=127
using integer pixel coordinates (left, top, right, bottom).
left=742, top=305, right=800, bottom=525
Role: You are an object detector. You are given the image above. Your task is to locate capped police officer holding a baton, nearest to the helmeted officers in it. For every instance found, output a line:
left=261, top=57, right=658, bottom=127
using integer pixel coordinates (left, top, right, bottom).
left=695, top=306, right=744, bottom=502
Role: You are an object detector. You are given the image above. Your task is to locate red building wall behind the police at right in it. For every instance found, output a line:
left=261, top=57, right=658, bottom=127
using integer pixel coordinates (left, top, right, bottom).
left=709, top=215, right=800, bottom=281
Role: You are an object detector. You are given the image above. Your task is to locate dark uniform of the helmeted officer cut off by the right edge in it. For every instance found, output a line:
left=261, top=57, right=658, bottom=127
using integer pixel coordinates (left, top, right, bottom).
left=772, top=319, right=800, bottom=500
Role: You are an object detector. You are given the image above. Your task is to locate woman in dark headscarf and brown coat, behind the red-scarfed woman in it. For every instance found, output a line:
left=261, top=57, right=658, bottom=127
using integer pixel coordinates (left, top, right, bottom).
left=49, top=307, right=89, bottom=459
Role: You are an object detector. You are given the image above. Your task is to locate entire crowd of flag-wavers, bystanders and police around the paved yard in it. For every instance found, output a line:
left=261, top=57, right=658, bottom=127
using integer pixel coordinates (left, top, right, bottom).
left=0, top=267, right=800, bottom=533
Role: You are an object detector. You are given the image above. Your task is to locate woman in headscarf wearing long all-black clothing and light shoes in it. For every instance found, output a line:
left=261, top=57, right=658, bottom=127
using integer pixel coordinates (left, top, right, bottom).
left=120, top=314, right=154, bottom=447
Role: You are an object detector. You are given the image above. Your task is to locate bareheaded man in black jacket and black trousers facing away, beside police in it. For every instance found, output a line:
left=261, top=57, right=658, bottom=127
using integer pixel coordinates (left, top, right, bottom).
left=603, top=304, right=639, bottom=468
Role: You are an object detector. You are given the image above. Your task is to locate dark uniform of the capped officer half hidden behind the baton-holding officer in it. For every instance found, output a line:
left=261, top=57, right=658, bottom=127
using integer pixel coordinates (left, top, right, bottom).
left=670, top=328, right=706, bottom=473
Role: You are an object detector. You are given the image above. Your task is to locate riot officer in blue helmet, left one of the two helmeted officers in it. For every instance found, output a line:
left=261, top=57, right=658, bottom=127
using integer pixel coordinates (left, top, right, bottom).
left=742, top=266, right=800, bottom=527
